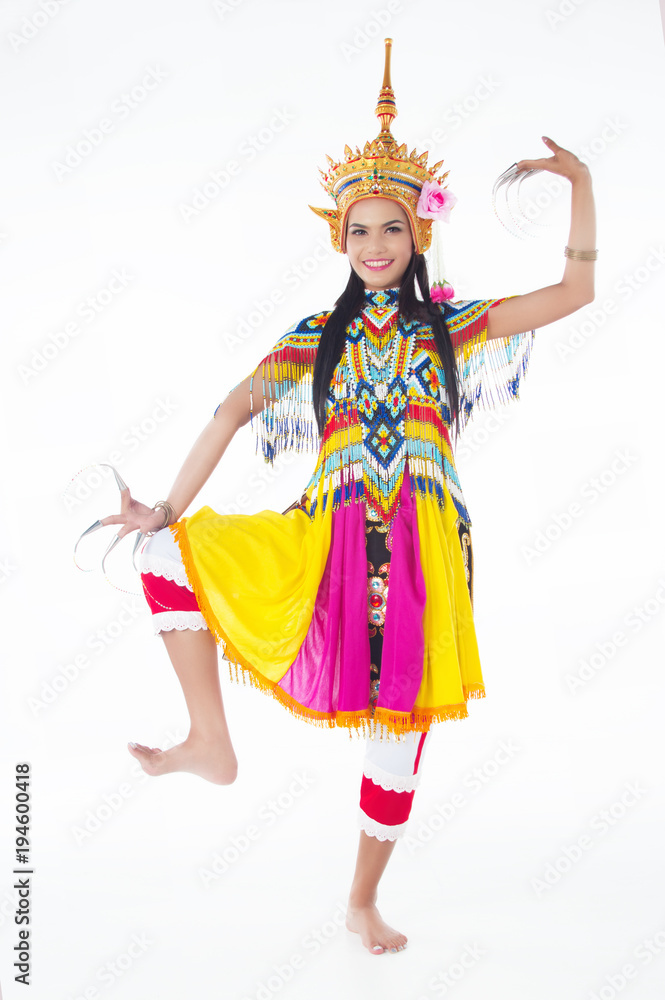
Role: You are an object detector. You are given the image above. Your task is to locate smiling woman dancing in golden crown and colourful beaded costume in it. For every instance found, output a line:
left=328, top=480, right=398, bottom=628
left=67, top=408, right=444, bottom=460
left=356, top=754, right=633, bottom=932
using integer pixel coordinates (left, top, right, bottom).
left=94, top=40, right=596, bottom=954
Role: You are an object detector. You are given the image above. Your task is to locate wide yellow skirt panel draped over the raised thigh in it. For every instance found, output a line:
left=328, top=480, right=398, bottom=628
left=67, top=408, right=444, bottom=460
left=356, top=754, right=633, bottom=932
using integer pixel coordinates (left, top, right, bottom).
left=176, top=504, right=332, bottom=682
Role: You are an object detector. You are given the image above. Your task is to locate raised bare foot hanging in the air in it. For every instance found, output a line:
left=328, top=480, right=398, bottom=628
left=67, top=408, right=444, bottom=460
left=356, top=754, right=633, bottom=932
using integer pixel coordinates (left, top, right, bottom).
left=127, top=733, right=238, bottom=785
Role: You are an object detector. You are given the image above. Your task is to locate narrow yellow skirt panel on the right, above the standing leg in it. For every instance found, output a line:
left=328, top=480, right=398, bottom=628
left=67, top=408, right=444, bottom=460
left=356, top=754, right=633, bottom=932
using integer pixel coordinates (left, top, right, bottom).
left=415, top=489, right=484, bottom=709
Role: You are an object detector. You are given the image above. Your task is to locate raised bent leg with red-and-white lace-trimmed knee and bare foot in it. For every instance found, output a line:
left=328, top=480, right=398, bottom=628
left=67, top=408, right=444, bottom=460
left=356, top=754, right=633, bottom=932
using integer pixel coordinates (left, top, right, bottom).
left=128, top=529, right=238, bottom=785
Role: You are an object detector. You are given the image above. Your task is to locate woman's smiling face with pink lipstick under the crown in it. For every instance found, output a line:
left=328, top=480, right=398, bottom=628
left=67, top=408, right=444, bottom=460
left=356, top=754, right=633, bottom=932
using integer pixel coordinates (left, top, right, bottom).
left=346, top=198, right=414, bottom=291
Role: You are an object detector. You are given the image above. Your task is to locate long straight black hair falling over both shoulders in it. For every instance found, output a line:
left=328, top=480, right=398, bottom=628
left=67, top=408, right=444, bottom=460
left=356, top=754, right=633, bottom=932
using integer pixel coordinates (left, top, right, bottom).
left=312, top=252, right=460, bottom=444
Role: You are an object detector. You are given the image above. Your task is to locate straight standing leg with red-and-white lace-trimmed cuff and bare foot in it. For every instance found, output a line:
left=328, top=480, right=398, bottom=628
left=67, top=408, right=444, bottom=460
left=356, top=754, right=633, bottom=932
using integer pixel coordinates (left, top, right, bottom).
left=346, top=732, right=429, bottom=955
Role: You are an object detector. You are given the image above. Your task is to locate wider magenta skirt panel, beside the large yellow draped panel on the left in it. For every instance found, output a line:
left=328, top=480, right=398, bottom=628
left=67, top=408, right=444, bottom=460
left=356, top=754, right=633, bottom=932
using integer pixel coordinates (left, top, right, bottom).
left=278, top=492, right=370, bottom=712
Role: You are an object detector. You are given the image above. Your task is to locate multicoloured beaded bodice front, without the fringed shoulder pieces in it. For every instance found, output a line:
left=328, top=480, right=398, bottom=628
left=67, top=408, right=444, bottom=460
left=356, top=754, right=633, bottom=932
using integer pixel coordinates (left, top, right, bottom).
left=320, top=288, right=452, bottom=523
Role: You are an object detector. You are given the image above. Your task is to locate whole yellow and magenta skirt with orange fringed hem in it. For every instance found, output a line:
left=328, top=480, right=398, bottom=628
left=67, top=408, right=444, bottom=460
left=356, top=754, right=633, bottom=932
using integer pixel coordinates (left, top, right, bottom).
left=171, top=467, right=485, bottom=733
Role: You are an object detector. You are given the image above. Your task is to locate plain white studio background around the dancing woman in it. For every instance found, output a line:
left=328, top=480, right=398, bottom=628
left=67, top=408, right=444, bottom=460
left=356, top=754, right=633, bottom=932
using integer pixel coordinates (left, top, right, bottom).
left=0, top=0, right=665, bottom=1000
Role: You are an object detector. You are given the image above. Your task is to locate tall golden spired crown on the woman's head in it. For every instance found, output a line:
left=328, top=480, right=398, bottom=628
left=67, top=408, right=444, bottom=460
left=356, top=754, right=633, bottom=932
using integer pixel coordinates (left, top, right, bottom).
left=309, top=38, right=448, bottom=253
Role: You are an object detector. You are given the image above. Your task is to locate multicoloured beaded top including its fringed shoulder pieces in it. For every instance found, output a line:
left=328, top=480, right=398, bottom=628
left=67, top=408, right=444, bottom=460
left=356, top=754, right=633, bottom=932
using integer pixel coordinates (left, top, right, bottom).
left=241, top=288, right=533, bottom=525
